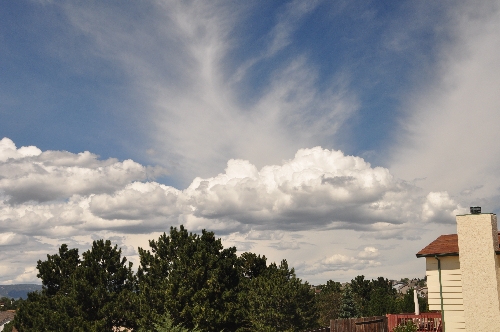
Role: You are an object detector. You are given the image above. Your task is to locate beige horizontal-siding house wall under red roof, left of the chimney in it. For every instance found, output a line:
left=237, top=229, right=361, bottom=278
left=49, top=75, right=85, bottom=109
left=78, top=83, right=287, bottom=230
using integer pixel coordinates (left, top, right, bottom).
left=425, top=256, right=465, bottom=332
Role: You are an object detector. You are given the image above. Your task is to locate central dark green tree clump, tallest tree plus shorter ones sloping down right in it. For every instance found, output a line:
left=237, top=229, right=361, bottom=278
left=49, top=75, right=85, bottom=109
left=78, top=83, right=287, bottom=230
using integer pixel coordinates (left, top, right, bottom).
left=137, top=226, right=317, bottom=331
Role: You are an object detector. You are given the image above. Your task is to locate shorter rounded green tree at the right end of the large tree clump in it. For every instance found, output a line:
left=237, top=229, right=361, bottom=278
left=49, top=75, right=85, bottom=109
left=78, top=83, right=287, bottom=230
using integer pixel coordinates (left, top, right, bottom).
left=241, top=260, right=317, bottom=332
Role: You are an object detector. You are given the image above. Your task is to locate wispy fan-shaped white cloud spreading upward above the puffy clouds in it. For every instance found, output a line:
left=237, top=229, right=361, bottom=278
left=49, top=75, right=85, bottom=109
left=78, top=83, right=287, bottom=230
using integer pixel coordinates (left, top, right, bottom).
left=58, top=1, right=359, bottom=186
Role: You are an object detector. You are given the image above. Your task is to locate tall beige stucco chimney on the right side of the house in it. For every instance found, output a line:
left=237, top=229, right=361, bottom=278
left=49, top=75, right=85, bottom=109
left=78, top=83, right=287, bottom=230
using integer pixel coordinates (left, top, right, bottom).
left=458, top=214, right=500, bottom=332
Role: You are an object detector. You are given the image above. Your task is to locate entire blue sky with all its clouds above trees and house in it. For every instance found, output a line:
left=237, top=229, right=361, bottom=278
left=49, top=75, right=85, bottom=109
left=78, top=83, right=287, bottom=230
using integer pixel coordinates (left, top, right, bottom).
left=0, top=0, right=500, bottom=284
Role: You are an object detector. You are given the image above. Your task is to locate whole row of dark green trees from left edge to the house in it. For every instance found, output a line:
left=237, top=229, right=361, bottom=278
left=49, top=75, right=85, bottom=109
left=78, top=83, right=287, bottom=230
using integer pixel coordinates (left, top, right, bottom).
left=6, top=226, right=426, bottom=332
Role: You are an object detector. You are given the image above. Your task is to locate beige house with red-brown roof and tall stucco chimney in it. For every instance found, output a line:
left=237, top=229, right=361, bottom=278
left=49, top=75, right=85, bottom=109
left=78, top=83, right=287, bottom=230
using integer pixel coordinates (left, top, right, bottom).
left=417, top=208, right=500, bottom=332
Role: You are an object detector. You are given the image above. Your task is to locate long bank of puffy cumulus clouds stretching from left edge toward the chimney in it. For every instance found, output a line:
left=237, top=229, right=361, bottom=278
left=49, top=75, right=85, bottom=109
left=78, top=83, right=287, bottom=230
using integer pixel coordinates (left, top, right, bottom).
left=0, top=139, right=460, bottom=241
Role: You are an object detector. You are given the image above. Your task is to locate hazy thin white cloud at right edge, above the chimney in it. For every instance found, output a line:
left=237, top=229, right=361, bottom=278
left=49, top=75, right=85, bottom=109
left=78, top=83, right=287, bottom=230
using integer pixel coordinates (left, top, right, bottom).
left=390, top=1, right=500, bottom=213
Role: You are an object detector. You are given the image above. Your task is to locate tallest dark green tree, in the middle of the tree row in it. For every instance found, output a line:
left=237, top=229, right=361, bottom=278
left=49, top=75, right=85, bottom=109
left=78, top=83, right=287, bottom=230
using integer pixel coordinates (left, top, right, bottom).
left=138, top=226, right=240, bottom=331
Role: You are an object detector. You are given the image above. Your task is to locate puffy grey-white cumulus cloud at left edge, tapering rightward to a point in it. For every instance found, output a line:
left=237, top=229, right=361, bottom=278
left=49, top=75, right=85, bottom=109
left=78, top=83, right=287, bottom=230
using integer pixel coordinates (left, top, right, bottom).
left=0, top=138, right=164, bottom=203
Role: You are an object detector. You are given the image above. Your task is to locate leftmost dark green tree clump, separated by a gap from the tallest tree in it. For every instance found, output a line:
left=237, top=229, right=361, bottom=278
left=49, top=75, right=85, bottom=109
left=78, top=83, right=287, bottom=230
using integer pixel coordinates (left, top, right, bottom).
left=14, top=240, right=136, bottom=332
